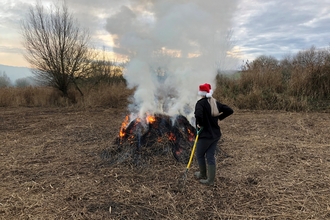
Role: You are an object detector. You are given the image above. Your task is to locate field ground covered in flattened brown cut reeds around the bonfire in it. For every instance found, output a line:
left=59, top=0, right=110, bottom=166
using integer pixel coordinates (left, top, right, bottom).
left=0, top=108, right=330, bottom=219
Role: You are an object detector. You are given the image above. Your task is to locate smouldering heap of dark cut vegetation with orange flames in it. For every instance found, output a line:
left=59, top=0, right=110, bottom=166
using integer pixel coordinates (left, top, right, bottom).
left=101, top=114, right=196, bottom=165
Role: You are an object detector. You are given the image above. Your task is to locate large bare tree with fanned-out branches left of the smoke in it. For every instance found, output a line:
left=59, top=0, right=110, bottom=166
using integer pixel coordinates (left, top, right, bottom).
left=22, top=1, right=93, bottom=97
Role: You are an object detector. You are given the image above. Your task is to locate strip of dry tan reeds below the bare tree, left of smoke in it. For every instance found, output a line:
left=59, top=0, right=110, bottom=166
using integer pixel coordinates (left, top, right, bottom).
left=0, top=83, right=133, bottom=108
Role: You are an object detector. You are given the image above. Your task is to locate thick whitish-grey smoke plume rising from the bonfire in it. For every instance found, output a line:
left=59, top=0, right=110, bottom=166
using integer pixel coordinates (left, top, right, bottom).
left=106, top=0, right=237, bottom=118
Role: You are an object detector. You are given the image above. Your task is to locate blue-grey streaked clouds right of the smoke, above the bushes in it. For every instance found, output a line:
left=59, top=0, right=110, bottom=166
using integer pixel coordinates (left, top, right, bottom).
left=234, top=0, right=330, bottom=59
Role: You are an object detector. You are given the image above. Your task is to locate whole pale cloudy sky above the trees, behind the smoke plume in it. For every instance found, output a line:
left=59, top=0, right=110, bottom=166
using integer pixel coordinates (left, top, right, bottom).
left=0, top=0, right=330, bottom=66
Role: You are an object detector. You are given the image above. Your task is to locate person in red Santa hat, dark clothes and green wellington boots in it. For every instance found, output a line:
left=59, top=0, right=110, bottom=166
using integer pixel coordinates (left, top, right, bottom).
left=195, top=83, right=234, bottom=185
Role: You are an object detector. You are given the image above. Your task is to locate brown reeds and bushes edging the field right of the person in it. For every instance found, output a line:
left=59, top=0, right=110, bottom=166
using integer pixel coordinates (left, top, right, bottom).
left=217, top=46, right=330, bottom=111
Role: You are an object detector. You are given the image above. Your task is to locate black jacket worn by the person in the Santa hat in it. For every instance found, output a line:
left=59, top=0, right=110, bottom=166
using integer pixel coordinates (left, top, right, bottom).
left=195, top=97, right=234, bottom=139
